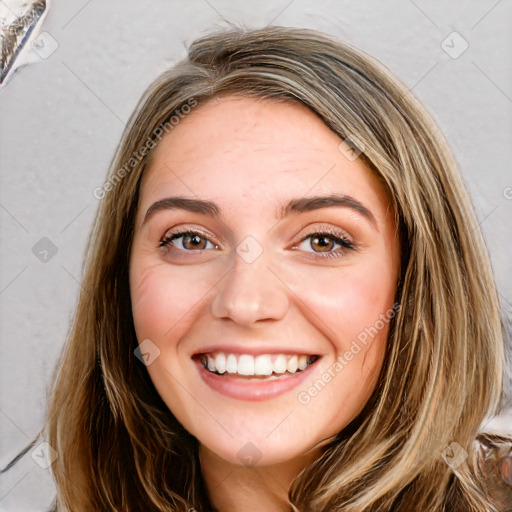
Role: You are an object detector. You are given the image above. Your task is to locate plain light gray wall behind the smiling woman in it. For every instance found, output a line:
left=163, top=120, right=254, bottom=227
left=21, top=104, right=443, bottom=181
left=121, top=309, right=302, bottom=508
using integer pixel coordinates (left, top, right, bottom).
left=0, top=0, right=512, bottom=512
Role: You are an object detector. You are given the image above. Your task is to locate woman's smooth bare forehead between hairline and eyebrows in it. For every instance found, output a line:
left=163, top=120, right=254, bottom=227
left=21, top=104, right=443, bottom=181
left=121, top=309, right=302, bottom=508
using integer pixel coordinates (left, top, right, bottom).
left=141, top=96, right=388, bottom=220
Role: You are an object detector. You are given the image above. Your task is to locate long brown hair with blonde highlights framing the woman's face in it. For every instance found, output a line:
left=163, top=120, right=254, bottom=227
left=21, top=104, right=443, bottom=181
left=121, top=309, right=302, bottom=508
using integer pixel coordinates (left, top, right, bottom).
left=5, top=26, right=512, bottom=512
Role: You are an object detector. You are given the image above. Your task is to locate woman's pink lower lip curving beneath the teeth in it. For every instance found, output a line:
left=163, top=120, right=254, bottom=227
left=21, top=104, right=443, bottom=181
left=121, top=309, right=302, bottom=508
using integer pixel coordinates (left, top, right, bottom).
left=195, top=359, right=318, bottom=402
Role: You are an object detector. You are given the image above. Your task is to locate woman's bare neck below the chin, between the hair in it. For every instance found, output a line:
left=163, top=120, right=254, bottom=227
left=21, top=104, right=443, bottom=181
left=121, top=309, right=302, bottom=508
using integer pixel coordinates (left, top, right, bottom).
left=199, top=445, right=320, bottom=512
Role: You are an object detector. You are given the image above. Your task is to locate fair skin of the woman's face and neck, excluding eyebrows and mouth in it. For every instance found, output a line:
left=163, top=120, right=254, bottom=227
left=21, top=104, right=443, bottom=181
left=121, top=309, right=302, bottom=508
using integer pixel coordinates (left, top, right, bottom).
left=130, top=96, right=400, bottom=512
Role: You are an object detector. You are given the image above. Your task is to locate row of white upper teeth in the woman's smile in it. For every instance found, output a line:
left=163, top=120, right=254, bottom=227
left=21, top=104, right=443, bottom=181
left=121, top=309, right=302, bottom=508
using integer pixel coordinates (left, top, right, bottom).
left=201, top=352, right=314, bottom=375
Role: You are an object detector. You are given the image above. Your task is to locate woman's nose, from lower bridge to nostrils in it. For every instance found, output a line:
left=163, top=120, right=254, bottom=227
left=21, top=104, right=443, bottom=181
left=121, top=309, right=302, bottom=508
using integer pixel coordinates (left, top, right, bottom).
left=211, top=254, right=289, bottom=325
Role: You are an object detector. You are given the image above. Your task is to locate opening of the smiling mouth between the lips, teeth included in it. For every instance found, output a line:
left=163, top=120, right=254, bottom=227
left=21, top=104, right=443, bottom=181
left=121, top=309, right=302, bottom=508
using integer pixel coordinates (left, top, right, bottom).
left=194, top=352, right=319, bottom=380
